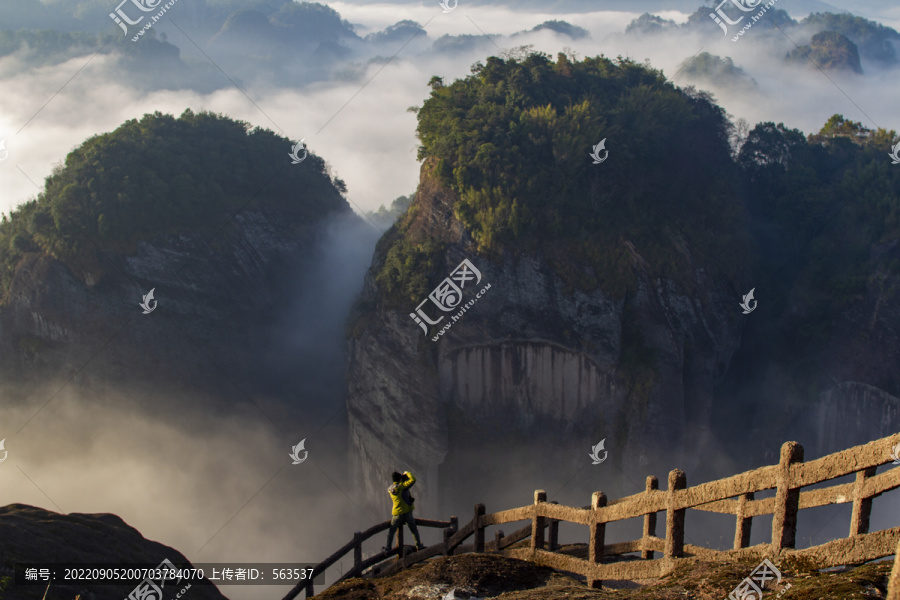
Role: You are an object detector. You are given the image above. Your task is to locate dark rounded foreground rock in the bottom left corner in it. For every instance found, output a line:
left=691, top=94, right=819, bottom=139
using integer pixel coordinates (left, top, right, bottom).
left=0, top=504, right=225, bottom=600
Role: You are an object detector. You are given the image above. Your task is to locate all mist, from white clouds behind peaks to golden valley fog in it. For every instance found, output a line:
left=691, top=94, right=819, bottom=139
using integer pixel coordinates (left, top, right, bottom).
left=0, top=0, right=900, bottom=599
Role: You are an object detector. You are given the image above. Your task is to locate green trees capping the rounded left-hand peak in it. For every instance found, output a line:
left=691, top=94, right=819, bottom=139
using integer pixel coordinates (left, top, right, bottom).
left=0, top=110, right=348, bottom=296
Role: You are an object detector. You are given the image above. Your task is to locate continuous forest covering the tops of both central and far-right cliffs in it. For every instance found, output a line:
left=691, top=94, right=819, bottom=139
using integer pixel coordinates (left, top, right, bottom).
left=379, top=54, right=900, bottom=310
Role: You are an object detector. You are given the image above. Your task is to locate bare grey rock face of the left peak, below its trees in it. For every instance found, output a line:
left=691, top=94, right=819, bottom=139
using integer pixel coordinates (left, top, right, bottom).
left=0, top=209, right=344, bottom=398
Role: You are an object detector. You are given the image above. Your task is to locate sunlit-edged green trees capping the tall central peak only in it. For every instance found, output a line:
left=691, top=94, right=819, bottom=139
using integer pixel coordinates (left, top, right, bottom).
left=379, top=53, right=747, bottom=299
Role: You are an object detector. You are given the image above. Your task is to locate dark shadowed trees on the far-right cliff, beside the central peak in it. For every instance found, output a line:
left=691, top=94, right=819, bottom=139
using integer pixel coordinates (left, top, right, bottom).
left=738, top=115, right=900, bottom=407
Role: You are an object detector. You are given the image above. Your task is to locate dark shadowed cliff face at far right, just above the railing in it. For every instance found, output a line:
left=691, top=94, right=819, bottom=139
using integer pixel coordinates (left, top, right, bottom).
left=736, top=236, right=900, bottom=464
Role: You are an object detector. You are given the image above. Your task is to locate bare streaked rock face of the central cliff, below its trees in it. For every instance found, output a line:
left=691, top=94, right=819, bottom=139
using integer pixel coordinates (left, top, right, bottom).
left=348, top=161, right=741, bottom=510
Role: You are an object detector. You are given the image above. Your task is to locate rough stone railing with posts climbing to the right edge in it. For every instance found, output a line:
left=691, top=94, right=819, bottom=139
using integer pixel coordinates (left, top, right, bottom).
left=285, top=434, right=900, bottom=600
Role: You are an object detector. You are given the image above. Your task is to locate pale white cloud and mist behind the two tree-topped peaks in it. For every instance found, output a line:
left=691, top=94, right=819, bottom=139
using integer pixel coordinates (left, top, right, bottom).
left=0, top=0, right=900, bottom=218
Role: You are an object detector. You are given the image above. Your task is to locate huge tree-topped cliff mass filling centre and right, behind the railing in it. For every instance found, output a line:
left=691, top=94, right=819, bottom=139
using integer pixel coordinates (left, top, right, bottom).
left=348, top=54, right=900, bottom=513
